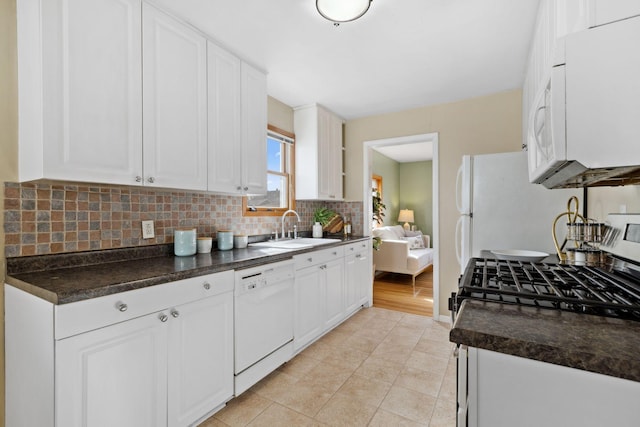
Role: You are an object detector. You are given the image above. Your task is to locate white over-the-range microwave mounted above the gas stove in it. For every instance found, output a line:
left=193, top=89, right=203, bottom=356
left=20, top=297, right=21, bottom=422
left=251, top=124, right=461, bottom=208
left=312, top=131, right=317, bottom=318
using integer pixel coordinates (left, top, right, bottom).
left=527, top=17, right=640, bottom=188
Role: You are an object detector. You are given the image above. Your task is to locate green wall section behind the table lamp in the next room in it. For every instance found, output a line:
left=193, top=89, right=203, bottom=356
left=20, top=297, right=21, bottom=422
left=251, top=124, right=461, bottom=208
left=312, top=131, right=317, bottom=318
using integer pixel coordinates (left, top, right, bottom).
left=400, top=161, right=433, bottom=235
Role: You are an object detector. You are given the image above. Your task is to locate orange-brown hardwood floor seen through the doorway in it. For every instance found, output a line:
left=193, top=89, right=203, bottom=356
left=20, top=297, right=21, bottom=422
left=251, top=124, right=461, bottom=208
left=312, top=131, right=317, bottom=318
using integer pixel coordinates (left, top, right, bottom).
left=373, top=268, right=433, bottom=317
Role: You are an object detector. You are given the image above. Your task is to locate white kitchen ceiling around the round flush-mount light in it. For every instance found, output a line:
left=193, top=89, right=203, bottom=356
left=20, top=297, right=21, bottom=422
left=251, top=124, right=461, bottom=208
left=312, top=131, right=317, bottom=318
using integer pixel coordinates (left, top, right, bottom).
left=151, top=0, right=539, bottom=120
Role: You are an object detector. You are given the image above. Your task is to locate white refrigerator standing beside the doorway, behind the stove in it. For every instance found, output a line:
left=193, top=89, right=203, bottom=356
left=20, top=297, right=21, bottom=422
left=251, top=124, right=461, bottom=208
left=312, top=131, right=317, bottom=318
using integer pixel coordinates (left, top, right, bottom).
left=456, top=151, right=582, bottom=273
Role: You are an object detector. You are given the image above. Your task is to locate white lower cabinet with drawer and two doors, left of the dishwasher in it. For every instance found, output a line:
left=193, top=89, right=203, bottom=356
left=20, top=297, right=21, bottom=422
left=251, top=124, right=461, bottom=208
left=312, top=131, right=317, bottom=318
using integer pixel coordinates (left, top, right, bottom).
left=5, top=271, right=234, bottom=427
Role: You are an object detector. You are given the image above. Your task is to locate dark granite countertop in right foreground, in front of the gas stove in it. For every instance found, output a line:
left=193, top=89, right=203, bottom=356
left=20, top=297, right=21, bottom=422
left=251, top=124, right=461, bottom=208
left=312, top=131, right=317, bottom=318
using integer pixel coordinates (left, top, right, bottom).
left=449, top=300, right=640, bottom=381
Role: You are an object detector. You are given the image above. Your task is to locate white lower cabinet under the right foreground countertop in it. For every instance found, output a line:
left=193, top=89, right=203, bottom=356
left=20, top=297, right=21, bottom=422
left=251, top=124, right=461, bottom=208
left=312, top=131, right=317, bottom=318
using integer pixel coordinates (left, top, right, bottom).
left=458, top=347, right=640, bottom=427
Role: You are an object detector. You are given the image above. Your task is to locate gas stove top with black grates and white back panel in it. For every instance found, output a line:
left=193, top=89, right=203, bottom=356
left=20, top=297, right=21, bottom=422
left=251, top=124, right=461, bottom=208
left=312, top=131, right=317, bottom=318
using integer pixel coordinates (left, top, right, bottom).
left=450, top=214, right=640, bottom=321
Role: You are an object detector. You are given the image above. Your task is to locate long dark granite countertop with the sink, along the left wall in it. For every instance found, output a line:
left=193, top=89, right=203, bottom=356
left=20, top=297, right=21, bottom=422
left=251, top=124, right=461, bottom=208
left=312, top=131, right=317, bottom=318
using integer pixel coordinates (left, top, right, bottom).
left=6, top=237, right=369, bottom=304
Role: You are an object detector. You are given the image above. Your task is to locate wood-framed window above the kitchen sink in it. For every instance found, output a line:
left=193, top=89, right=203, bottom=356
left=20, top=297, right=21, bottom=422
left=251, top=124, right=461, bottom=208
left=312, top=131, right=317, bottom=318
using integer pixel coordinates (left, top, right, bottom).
left=242, top=125, right=295, bottom=216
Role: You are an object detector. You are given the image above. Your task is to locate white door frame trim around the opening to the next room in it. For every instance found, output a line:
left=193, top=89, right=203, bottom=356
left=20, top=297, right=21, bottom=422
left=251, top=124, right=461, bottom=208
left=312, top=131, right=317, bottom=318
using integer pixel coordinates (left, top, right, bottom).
left=362, top=132, right=440, bottom=320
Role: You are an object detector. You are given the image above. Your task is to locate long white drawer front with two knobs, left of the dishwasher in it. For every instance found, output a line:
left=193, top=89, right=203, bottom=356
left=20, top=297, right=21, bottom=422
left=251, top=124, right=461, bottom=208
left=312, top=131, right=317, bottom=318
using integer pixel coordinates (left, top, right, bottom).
left=55, top=270, right=233, bottom=340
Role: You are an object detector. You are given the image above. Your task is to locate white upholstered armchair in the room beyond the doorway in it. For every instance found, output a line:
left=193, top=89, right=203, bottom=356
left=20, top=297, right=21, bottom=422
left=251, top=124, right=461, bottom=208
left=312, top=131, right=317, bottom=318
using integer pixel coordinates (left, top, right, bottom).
left=372, top=225, right=433, bottom=293
